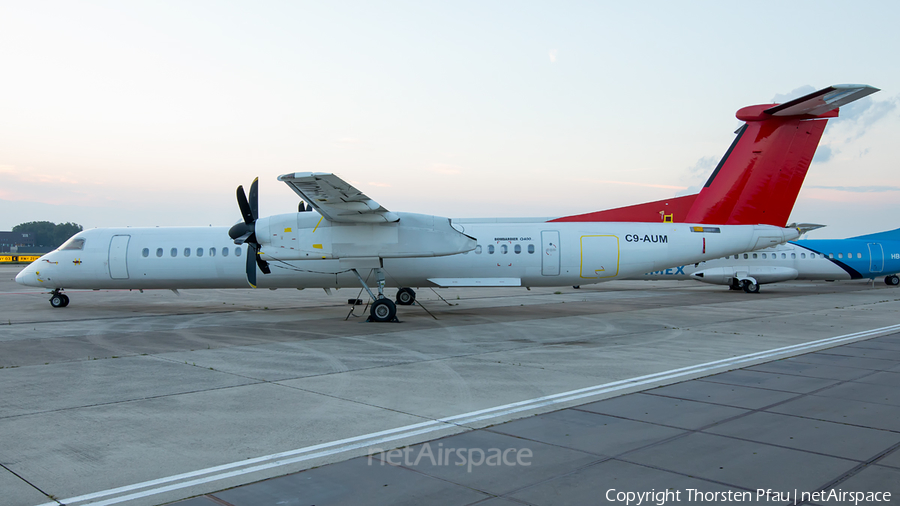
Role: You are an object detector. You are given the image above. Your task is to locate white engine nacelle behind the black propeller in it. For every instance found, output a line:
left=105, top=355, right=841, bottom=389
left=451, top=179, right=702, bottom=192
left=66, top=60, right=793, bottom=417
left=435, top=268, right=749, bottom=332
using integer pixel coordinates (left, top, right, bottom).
left=256, top=212, right=476, bottom=260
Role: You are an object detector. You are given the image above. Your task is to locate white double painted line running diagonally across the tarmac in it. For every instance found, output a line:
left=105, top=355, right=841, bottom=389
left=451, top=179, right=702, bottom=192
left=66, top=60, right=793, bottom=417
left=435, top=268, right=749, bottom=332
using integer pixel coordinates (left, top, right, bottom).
left=31, top=324, right=900, bottom=506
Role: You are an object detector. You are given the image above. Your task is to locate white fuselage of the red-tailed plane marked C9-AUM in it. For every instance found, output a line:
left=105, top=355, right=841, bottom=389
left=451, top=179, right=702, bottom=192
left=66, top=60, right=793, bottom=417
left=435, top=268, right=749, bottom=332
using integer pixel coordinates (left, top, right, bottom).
left=16, top=213, right=798, bottom=289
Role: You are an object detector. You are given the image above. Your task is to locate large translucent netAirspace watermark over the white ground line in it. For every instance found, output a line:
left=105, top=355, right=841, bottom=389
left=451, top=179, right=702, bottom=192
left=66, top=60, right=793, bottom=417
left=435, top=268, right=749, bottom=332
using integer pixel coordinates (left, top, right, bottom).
left=369, top=443, right=534, bottom=473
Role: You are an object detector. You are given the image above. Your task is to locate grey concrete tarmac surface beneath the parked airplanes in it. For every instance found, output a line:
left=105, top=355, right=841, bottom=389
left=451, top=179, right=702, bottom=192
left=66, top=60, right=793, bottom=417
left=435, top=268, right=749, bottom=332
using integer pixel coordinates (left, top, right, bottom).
left=0, top=266, right=900, bottom=506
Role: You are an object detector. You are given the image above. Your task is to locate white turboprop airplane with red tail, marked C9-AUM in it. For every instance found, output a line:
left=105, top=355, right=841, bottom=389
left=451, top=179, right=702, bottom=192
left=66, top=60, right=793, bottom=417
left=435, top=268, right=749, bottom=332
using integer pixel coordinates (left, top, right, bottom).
left=16, top=85, right=878, bottom=322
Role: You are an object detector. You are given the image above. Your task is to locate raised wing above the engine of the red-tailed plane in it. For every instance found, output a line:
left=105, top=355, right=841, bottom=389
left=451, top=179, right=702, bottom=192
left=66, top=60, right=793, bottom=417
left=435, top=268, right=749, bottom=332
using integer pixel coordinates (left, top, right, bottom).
left=278, top=172, right=400, bottom=223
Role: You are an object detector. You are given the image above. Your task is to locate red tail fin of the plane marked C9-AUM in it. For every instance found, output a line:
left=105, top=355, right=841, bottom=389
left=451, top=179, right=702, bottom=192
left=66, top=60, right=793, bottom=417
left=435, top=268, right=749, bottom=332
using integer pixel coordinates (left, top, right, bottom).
left=553, top=84, right=878, bottom=227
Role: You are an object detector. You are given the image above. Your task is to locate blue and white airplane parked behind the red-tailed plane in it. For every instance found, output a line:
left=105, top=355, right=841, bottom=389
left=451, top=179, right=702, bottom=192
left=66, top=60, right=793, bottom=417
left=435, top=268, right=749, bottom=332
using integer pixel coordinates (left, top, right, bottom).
left=632, top=228, right=900, bottom=293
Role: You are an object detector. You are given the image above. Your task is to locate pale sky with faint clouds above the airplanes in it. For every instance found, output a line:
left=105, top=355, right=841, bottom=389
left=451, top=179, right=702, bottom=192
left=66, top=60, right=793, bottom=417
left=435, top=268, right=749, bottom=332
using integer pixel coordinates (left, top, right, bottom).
left=0, top=0, right=900, bottom=238
